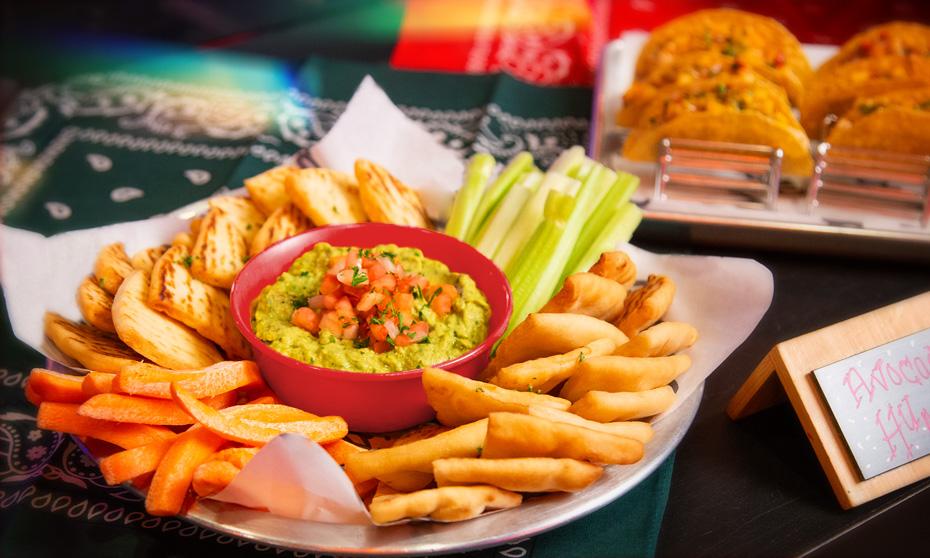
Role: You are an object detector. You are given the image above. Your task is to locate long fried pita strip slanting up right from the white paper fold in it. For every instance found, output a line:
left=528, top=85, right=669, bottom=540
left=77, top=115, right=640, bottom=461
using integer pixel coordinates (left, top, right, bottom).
left=346, top=419, right=488, bottom=483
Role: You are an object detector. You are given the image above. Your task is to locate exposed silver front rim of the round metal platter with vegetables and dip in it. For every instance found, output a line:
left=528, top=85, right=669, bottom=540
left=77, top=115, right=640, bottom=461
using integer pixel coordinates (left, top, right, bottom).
left=178, top=385, right=704, bottom=556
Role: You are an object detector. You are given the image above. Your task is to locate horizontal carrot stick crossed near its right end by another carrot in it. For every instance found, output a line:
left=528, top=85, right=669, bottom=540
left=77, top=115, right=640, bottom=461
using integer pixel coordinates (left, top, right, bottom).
left=78, top=392, right=235, bottom=426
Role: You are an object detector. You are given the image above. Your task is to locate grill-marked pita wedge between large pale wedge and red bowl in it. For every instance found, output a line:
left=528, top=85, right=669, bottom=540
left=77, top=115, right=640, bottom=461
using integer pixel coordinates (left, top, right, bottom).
left=147, top=246, right=251, bottom=359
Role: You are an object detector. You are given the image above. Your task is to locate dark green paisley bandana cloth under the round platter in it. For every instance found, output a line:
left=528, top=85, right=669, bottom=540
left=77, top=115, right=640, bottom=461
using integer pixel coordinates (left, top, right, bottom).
left=0, top=49, right=672, bottom=557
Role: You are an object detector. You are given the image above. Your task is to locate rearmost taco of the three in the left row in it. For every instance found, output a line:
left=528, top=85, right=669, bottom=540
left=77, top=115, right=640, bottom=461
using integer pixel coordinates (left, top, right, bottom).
left=636, top=9, right=812, bottom=94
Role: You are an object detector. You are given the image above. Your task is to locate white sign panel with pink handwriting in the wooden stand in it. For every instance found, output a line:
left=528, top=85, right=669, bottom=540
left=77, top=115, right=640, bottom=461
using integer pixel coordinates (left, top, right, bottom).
left=814, top=329, right=930, bottom=479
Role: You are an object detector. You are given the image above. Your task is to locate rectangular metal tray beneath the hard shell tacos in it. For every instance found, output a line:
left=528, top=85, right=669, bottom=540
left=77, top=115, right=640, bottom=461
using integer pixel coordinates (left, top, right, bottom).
left=588, top=31, right=930, bottom=261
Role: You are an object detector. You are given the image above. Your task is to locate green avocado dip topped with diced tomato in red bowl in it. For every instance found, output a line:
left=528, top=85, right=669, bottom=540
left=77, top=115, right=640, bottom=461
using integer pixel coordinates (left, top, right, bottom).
left=252, top=243, right=491, bottom=373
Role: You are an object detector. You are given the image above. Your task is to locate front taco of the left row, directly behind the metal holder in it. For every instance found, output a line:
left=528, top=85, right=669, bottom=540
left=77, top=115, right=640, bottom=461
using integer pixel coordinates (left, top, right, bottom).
left=623, top=76, right=812, bottom=175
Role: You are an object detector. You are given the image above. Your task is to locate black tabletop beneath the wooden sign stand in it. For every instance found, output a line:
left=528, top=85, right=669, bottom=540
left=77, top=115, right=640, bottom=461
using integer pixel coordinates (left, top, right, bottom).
left=4, top=2, right=930, bottom=556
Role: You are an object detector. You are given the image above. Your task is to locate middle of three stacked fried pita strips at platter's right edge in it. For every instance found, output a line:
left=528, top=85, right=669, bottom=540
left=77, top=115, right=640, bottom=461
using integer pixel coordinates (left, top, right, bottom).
left=559, top=355, right=691, bottom=401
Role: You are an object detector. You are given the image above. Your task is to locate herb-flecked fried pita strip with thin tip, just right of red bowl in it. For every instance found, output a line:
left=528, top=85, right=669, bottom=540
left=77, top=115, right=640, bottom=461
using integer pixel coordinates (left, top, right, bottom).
left=488, top=339, right=616, bottom=393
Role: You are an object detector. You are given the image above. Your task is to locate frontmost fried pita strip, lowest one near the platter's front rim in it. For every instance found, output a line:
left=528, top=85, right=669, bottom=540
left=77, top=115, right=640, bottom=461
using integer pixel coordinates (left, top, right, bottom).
left=369, top=485, right=523, bottom=525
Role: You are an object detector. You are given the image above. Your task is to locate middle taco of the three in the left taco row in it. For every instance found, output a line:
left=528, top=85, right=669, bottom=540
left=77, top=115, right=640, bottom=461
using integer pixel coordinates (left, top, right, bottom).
left=617, top=50, right=804, bottom=126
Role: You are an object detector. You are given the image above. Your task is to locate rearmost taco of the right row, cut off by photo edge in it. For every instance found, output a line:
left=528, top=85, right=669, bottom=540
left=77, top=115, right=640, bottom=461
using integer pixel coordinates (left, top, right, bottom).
left=817, top=21, right=930, bottom=75
